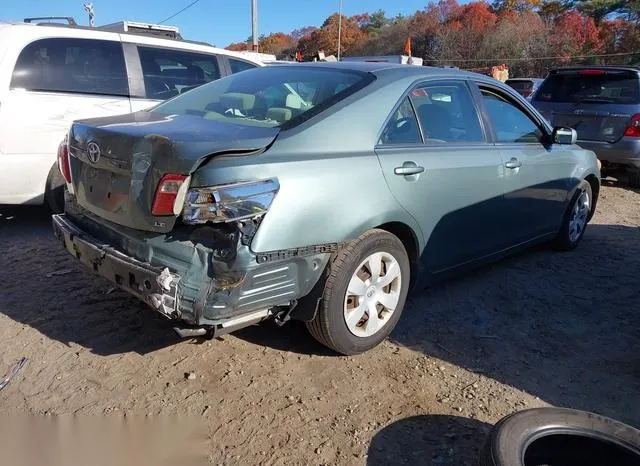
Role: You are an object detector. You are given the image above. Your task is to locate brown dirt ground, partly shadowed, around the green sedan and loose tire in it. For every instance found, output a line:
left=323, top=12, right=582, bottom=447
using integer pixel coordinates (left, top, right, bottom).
left=0, top=180, right=640, bottom=466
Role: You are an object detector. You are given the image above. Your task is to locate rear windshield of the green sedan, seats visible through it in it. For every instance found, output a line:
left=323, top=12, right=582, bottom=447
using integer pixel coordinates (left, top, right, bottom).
left=151, top=66, right=375, bottom=127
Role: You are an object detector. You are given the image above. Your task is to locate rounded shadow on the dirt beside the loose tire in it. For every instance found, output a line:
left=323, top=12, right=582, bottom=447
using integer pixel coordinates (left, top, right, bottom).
left=367, top=415, right=492, bottom=466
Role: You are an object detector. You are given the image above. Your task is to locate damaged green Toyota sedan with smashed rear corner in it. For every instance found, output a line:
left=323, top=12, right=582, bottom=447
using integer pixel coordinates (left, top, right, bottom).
left=53, top=63, right=600, bottom=354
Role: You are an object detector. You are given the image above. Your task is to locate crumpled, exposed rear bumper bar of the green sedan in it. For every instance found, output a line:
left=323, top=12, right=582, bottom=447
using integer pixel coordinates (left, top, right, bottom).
left=52, top=215, right=181, bottom=319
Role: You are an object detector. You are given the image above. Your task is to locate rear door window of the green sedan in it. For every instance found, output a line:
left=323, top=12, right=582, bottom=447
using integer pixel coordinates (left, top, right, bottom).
left=409, top=82, right=485, bottom=143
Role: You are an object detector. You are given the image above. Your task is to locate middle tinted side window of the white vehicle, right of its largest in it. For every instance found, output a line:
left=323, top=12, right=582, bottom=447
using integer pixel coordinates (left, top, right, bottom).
left=138, top=47, right=220, bottom=100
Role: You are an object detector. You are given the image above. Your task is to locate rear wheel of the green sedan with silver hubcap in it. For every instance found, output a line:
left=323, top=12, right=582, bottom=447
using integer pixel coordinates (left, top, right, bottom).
left=307, top=230, right=410, bottom=355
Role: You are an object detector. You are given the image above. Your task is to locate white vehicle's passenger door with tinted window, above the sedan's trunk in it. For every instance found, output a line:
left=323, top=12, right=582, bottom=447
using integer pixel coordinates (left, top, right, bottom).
left=126, top=44, right=223, bottom=112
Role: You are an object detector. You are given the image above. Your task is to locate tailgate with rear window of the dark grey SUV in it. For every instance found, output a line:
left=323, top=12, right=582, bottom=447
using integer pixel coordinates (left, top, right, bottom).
left=533, top=69, right=640, bottom=143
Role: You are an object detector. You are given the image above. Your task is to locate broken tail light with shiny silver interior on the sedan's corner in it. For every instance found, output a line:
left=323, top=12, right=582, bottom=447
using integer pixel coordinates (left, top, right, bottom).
left=182, top=178, right=280, bottom=224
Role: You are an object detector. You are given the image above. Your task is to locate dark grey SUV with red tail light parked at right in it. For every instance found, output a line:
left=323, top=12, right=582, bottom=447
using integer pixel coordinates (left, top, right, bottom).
left=532, top=66, right=640, bottom=188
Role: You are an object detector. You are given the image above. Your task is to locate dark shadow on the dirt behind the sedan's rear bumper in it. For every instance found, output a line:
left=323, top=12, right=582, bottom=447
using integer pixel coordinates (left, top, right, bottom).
left=0, top=206, right=182, bottom=356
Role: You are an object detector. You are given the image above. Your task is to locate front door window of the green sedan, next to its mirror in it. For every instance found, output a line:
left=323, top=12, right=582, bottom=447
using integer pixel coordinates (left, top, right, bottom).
left=482, top=89, right=542, bottom=143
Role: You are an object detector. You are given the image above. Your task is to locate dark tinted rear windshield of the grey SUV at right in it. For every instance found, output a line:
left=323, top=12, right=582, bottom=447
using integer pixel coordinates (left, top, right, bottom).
left=536, top=72, right=640, bottom=104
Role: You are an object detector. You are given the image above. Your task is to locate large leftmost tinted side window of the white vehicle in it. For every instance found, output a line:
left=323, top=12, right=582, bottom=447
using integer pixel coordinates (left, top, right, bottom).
left=11, top=38, right=129, bottom=96
